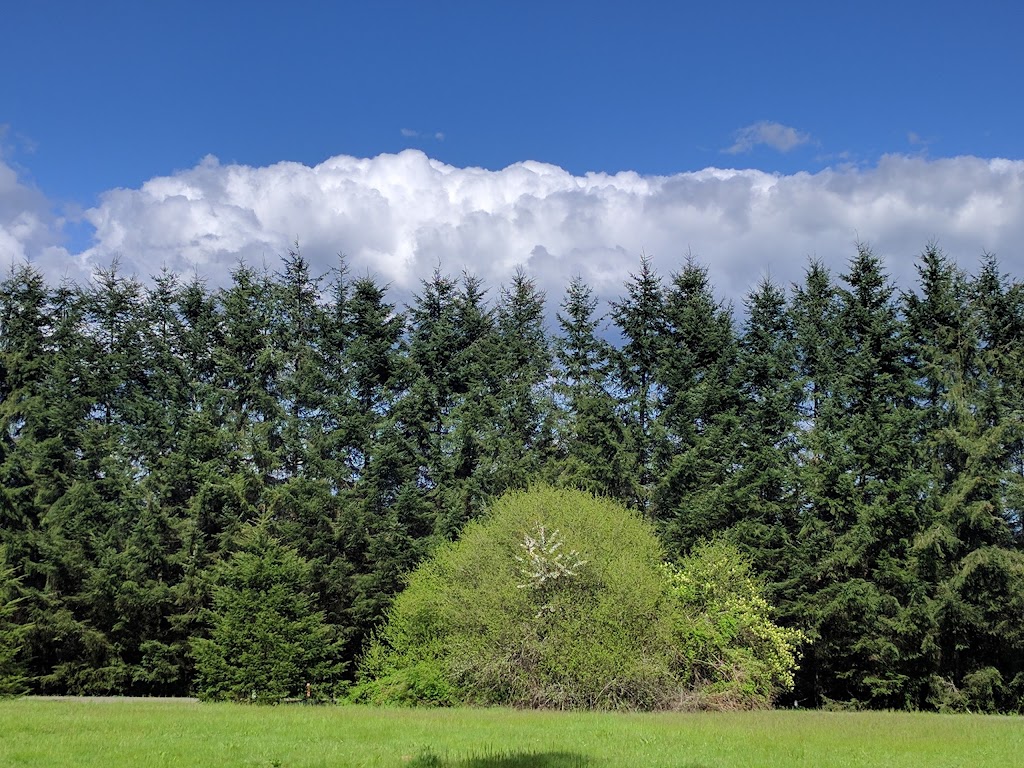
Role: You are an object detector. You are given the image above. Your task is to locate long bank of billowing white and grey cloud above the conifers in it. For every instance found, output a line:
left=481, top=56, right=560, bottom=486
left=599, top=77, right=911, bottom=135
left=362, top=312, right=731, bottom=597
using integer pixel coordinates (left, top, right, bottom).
left=0, top=151, right=1024, bottom=303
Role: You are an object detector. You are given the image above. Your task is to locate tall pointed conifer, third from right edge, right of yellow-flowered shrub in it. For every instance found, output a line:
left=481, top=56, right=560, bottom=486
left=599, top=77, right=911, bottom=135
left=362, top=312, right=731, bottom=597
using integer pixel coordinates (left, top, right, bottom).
left=805, top=246, right=925, bottom=707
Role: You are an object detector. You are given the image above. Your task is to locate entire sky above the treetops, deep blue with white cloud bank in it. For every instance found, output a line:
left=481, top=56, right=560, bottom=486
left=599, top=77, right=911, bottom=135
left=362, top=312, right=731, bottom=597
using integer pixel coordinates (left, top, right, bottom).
left=0, top=0, right=1024, bottom=305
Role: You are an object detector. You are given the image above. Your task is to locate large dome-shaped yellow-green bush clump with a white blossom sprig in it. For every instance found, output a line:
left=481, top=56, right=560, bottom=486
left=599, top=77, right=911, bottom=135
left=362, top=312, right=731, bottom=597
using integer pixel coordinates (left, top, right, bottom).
left=353, top=487, right=796, bottom=709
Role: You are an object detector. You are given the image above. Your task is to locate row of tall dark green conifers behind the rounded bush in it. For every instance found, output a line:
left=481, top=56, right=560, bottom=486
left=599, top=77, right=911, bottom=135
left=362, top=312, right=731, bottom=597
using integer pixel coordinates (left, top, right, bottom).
left=0, top=247, right=1024, bottom=712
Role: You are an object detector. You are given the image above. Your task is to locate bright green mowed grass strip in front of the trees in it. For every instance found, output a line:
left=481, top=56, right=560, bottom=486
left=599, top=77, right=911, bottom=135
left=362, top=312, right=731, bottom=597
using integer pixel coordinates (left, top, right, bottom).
left=0, top=699, right=1024, bottom=768
